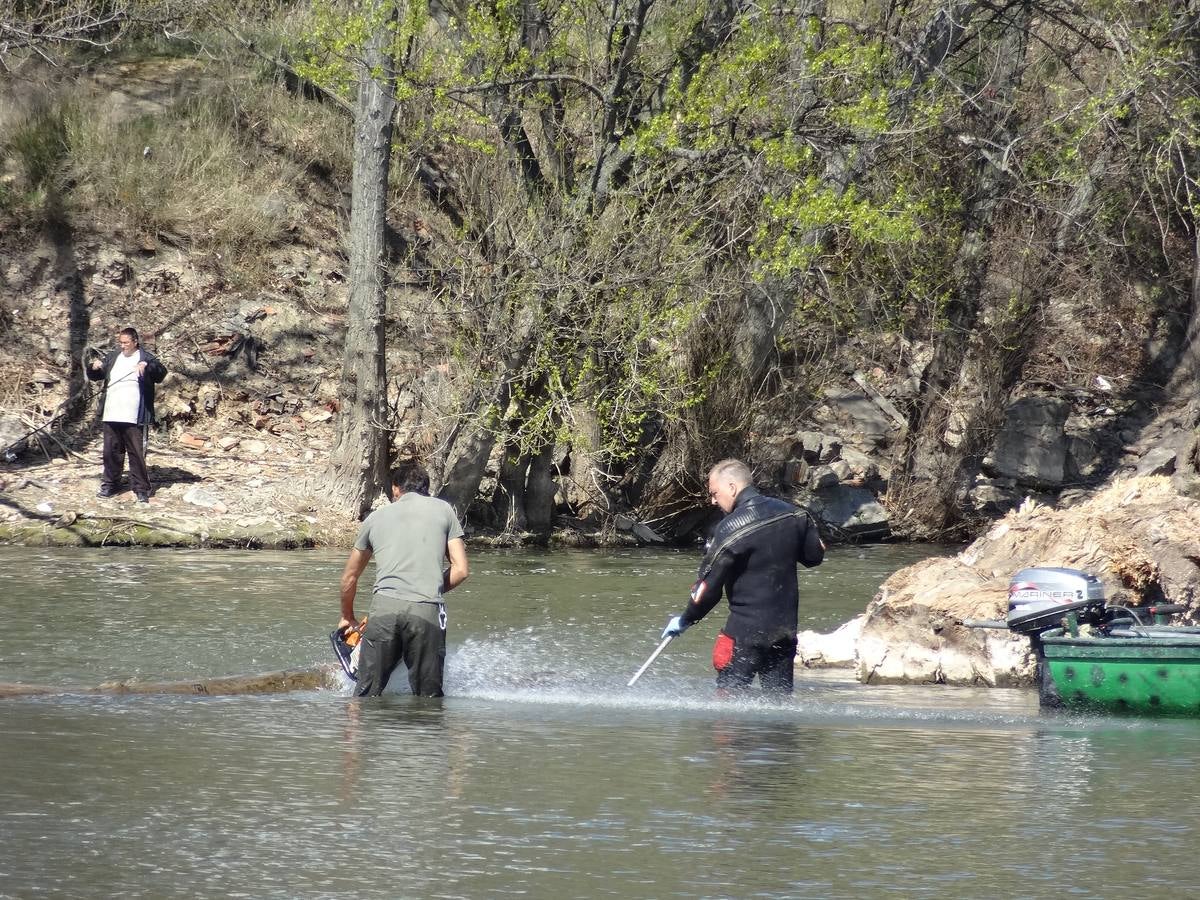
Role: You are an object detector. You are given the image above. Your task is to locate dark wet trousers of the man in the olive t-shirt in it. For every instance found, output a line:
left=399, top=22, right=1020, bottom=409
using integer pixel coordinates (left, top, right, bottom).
left=355, top=602, right=446, bottom=697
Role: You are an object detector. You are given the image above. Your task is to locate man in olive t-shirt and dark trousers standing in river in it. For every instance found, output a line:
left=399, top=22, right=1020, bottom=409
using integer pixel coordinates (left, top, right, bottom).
left=337, top=463, right=469, bottom=697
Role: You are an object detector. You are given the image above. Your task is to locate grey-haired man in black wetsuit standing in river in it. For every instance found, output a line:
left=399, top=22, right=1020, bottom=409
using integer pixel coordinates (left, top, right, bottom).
left=662, top=460, right=824, bottom=694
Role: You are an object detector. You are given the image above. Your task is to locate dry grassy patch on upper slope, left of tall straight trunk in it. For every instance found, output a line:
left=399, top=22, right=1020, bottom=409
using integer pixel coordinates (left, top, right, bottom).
left=0, top=2, right=353, bottom=273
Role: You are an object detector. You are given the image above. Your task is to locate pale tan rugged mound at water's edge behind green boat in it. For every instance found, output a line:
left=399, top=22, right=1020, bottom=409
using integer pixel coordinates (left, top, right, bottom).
left=799, top=475, right=1200, bottom=686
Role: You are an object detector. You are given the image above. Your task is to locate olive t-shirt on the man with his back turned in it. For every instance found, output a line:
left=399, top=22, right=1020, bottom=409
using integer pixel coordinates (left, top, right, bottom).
left=354, top=492, right=462, bottom=616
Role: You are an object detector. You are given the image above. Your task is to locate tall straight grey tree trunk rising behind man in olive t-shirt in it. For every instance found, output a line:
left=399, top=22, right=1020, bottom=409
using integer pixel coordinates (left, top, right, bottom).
left=326, top=0, right=396, bottom=517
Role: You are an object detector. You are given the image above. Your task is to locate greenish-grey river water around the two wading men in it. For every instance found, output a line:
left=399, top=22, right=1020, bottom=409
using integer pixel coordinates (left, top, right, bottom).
left=0, top=546, right=1200, bottom=898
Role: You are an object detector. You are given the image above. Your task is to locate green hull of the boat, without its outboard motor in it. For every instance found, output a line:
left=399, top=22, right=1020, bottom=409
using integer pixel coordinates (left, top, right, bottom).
left=1040, top=628, right=1200, bottom=718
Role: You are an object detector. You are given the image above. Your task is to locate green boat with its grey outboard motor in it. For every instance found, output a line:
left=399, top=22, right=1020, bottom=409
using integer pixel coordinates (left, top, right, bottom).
left=968, top=568, right=1200, bottom=718
